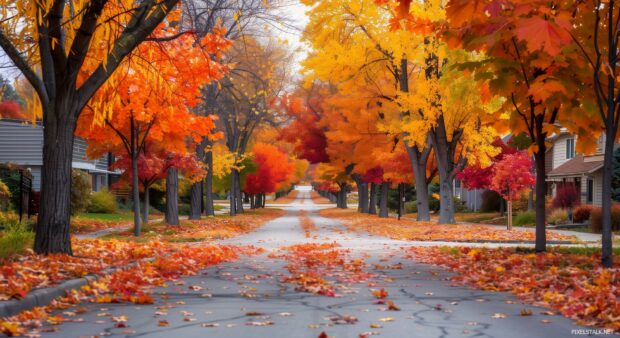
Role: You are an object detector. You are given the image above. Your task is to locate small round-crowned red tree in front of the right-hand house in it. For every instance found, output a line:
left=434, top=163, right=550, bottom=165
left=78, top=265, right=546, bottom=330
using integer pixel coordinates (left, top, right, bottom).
left=491, top=152, right=535, bottom=230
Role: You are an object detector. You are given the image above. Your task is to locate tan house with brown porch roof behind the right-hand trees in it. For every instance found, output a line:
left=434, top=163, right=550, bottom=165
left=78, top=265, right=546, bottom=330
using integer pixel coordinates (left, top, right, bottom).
left=546, top=128, right=605, bottom=206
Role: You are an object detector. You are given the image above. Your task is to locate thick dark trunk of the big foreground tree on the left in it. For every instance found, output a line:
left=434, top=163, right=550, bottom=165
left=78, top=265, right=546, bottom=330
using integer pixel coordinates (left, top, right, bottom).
left=34, top=113, right=75, bottom=255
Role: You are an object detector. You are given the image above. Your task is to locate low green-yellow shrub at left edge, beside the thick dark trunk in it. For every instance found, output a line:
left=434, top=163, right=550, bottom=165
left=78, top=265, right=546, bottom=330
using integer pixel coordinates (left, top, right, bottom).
left=0, top=213, right=34, bottom=258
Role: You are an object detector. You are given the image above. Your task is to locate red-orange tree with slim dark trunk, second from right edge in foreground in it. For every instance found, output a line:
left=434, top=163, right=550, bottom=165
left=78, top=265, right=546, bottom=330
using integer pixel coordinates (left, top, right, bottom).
left=445, top=0, right=594, bottom=252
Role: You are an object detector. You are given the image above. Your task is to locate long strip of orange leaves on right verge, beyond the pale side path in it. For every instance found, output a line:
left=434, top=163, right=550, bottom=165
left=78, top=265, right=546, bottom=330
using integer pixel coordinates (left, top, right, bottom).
left=320, top=209, right=575, bottom=242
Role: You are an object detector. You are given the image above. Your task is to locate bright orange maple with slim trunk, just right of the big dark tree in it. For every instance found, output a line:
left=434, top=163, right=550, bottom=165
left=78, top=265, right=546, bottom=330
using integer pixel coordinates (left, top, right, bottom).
left=76, top=26, right=230, bottom=236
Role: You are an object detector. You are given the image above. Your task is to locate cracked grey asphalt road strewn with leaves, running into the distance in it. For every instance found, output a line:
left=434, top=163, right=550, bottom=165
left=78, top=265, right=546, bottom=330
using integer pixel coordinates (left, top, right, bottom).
left=36, top=191, right=604, bottom=338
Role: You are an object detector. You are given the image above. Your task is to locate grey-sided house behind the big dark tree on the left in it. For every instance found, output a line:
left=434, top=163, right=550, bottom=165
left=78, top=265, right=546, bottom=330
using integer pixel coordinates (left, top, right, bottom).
left=0, top=119, right=117, bottom=191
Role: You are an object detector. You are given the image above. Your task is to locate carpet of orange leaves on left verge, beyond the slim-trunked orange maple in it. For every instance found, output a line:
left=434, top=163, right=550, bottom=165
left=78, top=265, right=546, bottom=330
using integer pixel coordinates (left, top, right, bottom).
left=114, top=209, right=284, bottom=242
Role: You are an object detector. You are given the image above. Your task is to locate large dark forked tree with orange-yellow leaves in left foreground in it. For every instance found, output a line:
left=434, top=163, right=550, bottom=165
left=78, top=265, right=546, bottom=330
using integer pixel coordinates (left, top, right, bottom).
left=0, top=0, right=179, bottom=254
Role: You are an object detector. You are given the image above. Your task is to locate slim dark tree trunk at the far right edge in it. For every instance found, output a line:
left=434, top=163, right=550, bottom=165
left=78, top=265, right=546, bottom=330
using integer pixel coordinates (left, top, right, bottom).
left=601, top=124, right=616, bottom=268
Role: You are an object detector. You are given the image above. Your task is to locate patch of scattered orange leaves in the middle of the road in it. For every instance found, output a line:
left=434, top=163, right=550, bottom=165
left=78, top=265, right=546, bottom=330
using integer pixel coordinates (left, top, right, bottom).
left=270, top=243, right=372, bottom=297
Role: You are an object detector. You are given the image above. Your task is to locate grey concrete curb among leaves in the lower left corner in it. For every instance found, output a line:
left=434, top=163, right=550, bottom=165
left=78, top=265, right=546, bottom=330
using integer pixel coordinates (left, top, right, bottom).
left=0, top=275, right=99, bottom=318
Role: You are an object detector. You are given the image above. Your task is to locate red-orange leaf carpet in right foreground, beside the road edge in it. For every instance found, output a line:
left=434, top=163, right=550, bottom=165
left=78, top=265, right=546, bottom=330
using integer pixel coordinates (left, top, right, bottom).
left=408, top=247, right=620, bottom=331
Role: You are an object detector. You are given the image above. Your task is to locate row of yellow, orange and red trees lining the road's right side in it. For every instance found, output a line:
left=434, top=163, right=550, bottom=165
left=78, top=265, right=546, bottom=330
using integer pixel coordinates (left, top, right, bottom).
left=284, top=0, right=620, bottom=266
